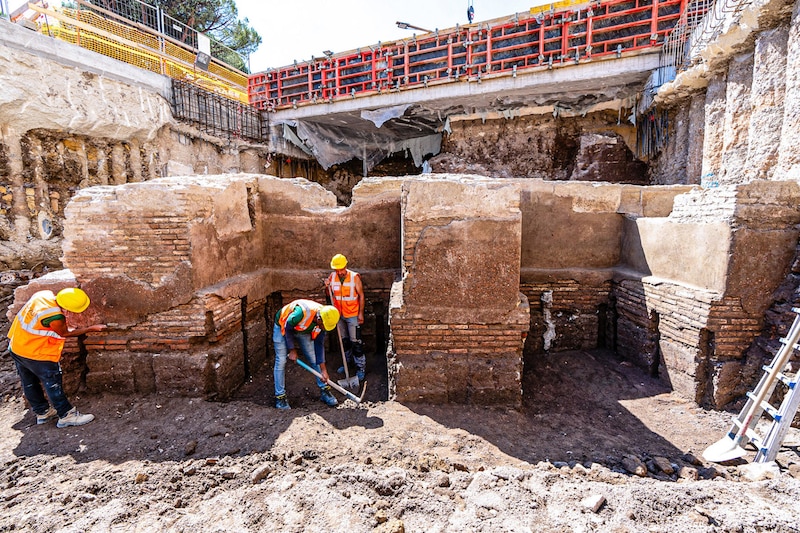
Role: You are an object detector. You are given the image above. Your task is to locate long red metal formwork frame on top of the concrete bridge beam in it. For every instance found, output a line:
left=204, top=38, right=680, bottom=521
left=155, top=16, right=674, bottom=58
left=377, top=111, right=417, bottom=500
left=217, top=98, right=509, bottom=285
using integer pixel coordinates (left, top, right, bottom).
left=248, top=0, right=687, bottom=110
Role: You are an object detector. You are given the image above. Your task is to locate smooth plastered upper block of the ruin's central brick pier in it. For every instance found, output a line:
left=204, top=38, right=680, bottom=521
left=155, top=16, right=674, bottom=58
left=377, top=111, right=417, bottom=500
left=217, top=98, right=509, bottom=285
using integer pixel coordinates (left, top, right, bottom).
left=402, top=179, right=522, bottom=323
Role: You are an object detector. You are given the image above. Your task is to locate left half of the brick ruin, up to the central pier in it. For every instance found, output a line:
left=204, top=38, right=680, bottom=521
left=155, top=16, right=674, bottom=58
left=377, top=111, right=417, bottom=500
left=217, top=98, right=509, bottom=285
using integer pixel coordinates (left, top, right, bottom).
left=9, top=175, right=400, bottom=398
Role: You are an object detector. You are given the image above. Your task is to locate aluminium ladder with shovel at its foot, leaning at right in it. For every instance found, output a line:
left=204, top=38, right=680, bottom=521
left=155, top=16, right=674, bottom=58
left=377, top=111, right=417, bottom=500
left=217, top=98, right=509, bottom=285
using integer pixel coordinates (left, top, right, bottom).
left=703, top=308, right=800, bottom=463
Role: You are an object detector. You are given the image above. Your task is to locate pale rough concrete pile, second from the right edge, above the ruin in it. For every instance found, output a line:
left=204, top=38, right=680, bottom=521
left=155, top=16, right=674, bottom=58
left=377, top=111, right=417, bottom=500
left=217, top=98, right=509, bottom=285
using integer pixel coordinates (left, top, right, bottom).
left=744, top=26, right=789, bottom=181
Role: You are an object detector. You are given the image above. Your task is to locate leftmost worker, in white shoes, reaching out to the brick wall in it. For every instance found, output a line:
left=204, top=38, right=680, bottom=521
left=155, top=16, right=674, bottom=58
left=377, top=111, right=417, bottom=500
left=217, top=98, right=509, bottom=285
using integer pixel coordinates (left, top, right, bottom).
left=8, top=288, right=106, bottom=428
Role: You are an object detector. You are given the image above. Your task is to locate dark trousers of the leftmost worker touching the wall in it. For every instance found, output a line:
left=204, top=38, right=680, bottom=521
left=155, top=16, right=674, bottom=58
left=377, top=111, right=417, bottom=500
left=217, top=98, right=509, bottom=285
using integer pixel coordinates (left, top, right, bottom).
left=9, top=352, right=72, bottom=418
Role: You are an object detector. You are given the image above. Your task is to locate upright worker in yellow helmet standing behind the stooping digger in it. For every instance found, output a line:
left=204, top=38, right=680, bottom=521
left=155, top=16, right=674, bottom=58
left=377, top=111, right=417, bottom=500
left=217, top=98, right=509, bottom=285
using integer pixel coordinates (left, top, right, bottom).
left=325, top=254, right=367, bottom=381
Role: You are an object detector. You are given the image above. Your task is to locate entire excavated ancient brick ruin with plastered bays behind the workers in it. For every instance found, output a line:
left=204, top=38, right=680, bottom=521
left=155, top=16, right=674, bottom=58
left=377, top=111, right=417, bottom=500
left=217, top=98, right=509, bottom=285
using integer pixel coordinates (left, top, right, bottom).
left=9, top=175, right=800, bottom=405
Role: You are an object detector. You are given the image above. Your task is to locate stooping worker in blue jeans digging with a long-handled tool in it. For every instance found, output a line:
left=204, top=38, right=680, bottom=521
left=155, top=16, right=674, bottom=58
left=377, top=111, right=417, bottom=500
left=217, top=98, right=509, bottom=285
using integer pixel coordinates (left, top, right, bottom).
left=272, top=300, right=339, bottom=410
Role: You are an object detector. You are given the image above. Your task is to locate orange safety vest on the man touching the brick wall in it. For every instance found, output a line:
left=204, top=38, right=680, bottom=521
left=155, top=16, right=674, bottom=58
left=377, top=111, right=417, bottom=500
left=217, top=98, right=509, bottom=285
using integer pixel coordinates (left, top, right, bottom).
left=8, top=291, right=64, bottom=363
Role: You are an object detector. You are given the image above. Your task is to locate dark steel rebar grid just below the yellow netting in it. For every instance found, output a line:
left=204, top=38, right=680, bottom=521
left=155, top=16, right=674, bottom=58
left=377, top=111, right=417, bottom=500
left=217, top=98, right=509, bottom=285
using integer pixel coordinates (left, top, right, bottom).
left=172, top=79, right=267, bottom=142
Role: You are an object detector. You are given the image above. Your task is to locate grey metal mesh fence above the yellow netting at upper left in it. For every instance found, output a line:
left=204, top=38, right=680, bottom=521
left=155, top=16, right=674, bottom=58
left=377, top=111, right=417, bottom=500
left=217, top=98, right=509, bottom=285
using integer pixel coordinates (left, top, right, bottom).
left=78, top=0, right=247, bottom=70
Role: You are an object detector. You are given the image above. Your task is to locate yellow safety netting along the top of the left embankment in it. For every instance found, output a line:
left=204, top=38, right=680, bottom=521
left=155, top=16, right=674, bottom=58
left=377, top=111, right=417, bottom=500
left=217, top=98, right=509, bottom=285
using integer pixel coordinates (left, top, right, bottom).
left=29, top=4, right=248, bottom=104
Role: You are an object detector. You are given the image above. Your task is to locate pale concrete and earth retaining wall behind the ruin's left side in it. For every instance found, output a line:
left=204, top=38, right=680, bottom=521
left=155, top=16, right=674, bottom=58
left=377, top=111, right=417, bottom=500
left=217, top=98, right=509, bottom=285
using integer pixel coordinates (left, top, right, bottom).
left=0, top=19, right=267, bottom=308
